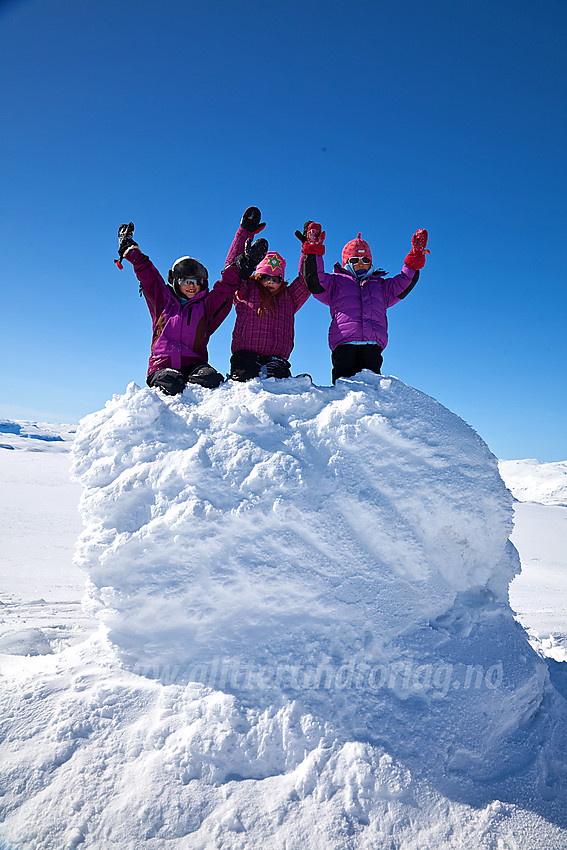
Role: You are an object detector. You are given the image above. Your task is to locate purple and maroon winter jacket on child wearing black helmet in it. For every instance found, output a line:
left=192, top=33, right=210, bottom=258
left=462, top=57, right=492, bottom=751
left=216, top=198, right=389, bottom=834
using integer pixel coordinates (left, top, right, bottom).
left=124, top=248, right=241, bottom=377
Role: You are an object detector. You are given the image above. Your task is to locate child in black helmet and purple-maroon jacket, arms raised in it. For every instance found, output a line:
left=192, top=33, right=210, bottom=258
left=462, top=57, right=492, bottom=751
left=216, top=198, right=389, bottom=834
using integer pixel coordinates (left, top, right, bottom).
left=116, top=217, right=268, bottom=395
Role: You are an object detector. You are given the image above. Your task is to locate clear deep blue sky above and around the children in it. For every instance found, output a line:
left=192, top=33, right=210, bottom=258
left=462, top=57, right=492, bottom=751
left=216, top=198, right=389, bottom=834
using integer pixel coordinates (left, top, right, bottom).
left=0, top=0, right=567, bottom=460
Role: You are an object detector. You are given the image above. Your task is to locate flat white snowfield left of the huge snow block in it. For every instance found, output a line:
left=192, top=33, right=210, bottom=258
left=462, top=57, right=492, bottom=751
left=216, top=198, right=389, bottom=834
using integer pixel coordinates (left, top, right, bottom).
left=0, top=420, right=90, bottom=654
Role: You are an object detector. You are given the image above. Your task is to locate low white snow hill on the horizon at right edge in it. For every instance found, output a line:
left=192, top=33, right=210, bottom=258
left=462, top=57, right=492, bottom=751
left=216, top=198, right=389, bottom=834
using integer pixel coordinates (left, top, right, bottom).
left=499, top=460, right=567, bottom=507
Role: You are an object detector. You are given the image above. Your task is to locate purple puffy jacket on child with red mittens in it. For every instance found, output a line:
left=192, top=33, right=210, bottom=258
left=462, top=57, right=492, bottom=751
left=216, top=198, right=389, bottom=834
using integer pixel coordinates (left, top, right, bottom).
left=302, top=255, right=419, bottom=351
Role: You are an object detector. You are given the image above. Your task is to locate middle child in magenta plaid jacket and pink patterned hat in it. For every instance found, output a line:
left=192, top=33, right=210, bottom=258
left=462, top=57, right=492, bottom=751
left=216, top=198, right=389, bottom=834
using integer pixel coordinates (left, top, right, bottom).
left=226, top=207, right=310, bottom=381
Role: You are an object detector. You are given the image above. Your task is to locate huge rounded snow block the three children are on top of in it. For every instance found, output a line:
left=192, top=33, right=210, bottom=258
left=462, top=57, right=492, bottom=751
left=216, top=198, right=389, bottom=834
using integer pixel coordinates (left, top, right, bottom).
left=74, top=378, right=519, bottom=679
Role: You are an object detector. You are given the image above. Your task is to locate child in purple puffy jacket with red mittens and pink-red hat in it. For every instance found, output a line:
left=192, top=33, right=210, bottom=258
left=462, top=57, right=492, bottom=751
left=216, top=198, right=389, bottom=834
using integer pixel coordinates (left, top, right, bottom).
left=295, top=221, right=429, bottom=384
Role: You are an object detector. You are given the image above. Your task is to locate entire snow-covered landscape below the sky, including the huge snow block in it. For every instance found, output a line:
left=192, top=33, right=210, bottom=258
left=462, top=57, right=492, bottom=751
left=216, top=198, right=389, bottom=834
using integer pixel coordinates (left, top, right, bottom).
left=0, top=380, right=567, bottom=850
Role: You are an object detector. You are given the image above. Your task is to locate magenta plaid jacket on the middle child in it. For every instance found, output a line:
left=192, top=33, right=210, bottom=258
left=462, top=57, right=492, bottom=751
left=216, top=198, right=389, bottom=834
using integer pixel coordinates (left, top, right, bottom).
left=226, top=227, right=310, bottom=360
